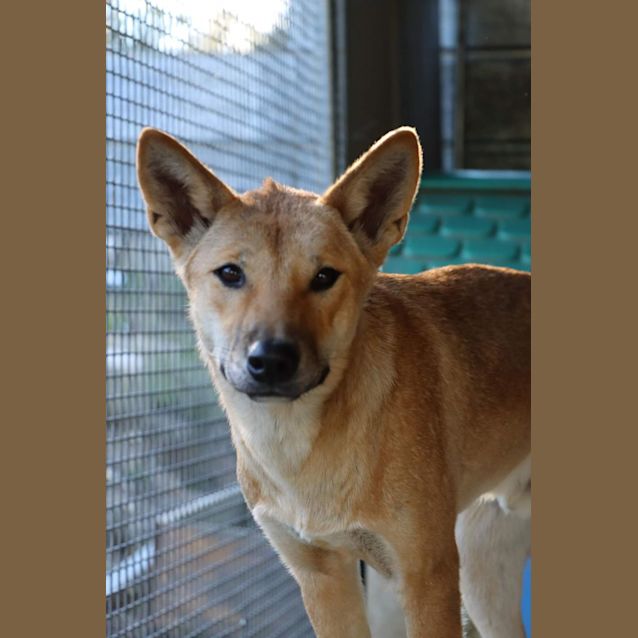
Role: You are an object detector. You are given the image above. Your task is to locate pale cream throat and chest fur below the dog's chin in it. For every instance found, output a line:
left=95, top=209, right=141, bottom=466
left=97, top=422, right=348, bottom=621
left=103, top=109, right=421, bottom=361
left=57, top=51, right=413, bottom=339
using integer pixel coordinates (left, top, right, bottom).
left=224, top=393, right=394, bottom=576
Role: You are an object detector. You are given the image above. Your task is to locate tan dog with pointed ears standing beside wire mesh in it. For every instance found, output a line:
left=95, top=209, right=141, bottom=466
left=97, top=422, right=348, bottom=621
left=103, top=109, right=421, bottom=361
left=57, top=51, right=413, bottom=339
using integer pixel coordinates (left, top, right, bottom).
left=137, top=128, right=530, bottom=638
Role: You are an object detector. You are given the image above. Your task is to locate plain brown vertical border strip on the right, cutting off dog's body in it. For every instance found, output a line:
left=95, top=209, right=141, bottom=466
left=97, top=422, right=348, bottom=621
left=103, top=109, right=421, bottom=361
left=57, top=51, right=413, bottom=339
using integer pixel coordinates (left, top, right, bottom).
left=532, top=2, right=638, bottom=638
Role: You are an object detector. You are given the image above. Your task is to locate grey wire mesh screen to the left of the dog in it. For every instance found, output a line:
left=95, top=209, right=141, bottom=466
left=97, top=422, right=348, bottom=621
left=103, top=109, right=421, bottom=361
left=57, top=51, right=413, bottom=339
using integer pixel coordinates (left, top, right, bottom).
left=106, top=0, right=334, bottom=638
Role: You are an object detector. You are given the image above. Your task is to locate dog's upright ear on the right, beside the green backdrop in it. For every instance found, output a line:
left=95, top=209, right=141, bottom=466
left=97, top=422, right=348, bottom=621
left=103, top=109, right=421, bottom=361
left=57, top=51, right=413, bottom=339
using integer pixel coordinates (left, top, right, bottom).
left=322, top=126, right=422, bottom=267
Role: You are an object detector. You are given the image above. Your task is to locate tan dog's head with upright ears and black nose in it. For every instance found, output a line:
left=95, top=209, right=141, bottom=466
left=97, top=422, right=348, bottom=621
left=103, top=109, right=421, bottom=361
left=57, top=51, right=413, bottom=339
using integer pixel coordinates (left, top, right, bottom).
left=137, top=128, right=421, bottom=401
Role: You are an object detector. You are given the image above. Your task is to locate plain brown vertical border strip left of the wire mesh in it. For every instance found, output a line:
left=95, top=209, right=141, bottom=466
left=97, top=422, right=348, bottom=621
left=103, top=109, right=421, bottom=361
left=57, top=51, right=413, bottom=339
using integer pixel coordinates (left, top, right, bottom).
left=0, top=2, right=105, bottom=638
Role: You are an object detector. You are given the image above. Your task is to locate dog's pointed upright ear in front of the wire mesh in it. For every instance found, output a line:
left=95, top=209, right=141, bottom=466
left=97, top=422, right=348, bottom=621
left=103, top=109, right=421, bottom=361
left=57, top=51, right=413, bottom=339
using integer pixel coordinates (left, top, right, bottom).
left=137, top=128, right=236, bottom=259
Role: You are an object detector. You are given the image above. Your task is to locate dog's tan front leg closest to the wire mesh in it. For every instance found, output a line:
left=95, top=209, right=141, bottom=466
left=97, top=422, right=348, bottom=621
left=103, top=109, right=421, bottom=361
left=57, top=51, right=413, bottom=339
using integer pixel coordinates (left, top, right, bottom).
left=256, top=517, right=370, bottom=638
